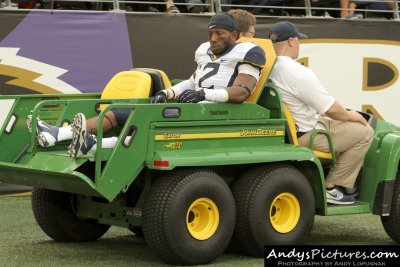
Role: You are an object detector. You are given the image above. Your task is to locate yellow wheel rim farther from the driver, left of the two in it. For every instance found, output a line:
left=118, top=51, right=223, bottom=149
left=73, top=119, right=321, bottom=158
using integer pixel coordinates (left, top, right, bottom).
left=186, top=198, right=219, bottom=240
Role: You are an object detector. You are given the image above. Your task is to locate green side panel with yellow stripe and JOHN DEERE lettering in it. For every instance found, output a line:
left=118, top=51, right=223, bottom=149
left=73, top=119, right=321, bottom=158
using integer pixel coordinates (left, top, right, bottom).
left=152, top=120, right=285, bottom=159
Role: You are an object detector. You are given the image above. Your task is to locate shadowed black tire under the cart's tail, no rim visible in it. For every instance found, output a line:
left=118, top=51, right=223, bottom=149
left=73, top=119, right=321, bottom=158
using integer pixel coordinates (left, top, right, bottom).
left=32, top=188, right=110, bottom=242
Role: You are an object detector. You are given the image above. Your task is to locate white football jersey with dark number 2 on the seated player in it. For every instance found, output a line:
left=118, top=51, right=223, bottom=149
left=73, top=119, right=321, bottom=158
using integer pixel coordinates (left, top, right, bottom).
left=194, top=42, right=266, bottom=90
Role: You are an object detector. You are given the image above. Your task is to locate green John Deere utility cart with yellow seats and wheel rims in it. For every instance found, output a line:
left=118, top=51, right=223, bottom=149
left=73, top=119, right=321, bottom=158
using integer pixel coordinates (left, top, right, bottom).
left=0, top=40, right=400, bottom=265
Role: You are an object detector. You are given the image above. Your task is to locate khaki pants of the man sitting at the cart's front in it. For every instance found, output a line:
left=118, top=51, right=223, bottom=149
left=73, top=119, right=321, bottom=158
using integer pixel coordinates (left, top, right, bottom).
left=299, top=117, right=374, bottom=188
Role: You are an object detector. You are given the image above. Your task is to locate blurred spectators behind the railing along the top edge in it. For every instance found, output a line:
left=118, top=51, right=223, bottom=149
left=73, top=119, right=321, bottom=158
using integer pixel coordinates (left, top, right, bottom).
left=0, top=0, right=398, bottom=19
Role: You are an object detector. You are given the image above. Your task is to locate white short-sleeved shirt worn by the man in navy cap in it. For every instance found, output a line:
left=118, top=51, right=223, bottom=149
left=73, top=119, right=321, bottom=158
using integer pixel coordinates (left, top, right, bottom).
left=269, top=56, right=335, bottom=132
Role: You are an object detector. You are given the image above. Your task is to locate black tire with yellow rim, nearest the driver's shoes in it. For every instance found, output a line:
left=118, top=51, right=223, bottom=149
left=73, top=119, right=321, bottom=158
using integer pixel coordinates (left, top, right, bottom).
left=232, top=164, right=315, bottom=257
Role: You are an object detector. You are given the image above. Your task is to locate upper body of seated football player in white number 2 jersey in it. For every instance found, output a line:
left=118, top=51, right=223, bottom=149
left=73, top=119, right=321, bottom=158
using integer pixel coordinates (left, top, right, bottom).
left=152, top=12, right=266, bottom=103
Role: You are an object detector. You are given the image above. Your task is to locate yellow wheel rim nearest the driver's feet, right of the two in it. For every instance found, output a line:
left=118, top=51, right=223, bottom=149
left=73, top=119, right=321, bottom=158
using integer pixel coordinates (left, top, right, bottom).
left=269, top=193, right=300, bottom=233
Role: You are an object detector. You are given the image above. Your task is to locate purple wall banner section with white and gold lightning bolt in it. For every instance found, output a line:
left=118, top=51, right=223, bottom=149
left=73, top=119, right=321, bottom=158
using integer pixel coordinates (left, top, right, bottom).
left=0, top=11, right=133, bottom=94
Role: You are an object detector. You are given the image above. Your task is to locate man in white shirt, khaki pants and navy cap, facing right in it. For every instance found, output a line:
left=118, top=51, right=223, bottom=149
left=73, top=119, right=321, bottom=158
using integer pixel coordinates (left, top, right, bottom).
left=269, top=21, right=374, bottom=205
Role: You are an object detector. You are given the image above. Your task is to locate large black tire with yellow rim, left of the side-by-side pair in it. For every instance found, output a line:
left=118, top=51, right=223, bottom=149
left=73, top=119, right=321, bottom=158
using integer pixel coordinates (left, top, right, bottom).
left=142, top=168, right=235, bottom=265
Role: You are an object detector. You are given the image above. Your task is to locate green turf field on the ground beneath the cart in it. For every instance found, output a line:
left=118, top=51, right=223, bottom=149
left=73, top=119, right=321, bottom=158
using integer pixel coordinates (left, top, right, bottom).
left=0, top=197, right=395, bottom=267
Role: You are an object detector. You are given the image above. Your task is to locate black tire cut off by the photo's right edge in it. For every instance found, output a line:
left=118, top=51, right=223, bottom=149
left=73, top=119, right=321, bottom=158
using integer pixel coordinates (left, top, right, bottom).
left=381, top=172, right=400, bottom=244
